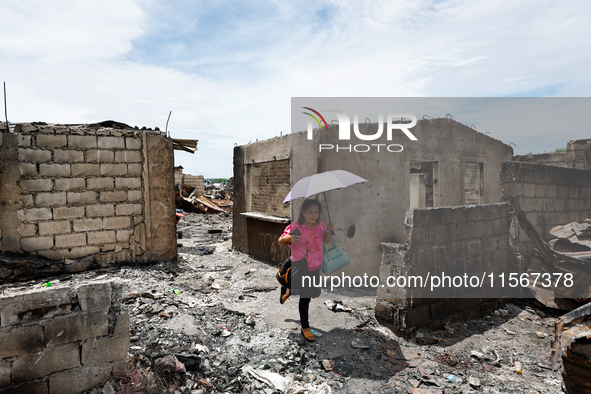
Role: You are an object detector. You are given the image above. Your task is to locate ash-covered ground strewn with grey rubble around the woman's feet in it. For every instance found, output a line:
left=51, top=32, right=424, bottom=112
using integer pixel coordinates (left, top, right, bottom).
left=9, top=213, right=562, bottom=394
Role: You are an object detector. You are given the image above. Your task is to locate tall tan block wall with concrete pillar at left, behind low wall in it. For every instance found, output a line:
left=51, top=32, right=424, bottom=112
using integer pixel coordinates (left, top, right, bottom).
left=0, top=125, right=176, bottom=278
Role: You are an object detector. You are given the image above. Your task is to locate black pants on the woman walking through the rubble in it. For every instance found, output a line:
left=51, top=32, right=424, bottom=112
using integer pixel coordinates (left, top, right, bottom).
left=290, top=259, right=321, bottom=328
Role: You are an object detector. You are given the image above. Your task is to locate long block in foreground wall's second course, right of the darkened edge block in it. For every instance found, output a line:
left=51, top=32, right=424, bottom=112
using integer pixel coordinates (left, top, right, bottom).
left=43, top=311, right=109, bottom=347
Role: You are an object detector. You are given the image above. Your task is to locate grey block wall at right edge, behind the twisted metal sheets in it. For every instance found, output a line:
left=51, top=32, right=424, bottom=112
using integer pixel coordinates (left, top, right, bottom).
left=501, top=161, right=591, bottom=269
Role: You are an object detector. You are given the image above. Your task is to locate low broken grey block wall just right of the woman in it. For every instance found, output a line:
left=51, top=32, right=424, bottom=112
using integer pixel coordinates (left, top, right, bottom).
left=375, top=203, right=512, bottom=334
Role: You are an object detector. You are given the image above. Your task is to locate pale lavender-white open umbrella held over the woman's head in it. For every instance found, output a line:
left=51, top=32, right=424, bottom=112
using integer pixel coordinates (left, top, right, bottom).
left=283, top=170, right=369, bottom=228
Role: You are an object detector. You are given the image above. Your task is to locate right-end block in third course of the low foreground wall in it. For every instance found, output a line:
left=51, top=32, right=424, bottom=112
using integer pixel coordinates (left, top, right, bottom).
left=82, top=335, right=130, bottom=366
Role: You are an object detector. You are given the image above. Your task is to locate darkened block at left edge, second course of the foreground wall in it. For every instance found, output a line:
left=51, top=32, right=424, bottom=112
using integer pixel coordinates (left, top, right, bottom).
left=0, top=326, right=44, bottom=358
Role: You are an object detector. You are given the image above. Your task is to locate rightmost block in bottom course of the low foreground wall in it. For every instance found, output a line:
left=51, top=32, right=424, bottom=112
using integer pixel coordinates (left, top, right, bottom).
left=49, top=364, right=113, bottom=394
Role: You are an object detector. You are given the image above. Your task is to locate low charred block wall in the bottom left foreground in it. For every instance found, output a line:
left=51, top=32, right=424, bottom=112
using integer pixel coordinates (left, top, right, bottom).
left=0, top=280, right=130, bottom=394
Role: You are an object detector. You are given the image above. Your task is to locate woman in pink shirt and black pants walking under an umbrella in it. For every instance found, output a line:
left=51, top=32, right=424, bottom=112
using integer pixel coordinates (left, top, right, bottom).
left=279, top=199, right=334, bottom=341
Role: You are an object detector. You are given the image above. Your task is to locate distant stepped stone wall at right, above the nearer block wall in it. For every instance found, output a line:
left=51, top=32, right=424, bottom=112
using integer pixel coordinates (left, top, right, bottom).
left=513, top=139, right=591, bottom=169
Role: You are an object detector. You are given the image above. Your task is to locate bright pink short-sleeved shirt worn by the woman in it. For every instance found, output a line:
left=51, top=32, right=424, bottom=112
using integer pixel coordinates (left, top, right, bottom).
left=281, top=222, right=326, bottom=271
